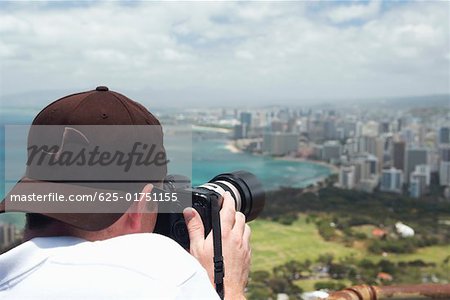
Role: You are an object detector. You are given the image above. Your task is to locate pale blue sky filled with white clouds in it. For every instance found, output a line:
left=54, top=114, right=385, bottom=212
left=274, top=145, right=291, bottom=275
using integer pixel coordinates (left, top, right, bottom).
left=0, top=0, right=450, bottom=107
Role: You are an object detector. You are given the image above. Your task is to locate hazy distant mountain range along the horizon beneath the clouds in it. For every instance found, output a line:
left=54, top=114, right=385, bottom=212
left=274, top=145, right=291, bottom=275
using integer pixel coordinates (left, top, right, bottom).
left=0, top=87, right=450, bottom=111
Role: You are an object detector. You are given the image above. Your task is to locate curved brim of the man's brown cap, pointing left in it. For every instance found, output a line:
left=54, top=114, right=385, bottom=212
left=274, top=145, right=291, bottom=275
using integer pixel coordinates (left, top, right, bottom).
left=0, top=177, right=132, bottom=231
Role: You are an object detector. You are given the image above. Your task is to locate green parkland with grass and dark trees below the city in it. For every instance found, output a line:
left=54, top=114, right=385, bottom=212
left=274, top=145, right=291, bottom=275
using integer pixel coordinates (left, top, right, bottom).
left=248, top=187, right=450, bottom=299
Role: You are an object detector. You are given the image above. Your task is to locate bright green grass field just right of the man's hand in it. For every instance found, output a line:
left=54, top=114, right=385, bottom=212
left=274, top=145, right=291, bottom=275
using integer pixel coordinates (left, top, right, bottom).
left=250, top=215, right=450, bottom=271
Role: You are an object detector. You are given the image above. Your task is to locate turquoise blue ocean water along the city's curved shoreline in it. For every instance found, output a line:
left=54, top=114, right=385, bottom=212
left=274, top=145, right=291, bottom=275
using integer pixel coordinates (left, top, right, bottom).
left=0, top=111, right=330, bottom=198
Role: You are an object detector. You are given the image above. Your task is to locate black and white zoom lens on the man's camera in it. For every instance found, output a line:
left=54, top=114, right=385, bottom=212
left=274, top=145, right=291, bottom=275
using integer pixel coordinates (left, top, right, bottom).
left=202, top=171, right=265, bottom=221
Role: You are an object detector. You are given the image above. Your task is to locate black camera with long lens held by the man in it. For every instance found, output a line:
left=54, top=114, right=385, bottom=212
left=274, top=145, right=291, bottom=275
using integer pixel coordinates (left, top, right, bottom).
left=154, top=171, right=265, bottom=249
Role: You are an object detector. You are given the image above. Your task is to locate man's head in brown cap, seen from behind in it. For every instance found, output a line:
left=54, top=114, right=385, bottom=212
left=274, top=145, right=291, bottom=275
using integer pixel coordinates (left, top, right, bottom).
left=0, top=86, right=167, bottom=240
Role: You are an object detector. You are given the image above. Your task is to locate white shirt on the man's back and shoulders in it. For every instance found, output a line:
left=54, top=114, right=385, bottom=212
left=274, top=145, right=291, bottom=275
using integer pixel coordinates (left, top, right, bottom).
left=0, top=233, right=218, bottom=300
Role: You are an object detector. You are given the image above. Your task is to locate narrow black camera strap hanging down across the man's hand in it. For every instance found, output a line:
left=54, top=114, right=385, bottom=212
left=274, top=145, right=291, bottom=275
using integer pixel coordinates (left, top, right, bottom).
left=211, top=201, right=225, bottom=299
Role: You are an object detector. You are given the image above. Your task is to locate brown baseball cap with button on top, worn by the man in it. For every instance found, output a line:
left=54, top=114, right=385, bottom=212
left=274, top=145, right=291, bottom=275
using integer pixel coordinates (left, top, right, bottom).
left=0, top=86, right=167, bottom=231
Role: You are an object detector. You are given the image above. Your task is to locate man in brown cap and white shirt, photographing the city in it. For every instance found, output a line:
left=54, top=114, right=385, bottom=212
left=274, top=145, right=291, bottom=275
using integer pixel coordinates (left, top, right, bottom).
left=0, top=87, right=251, bottom=299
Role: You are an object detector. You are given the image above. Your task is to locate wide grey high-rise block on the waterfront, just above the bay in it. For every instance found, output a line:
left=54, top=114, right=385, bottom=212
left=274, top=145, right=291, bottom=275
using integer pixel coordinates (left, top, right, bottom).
left=262, top=132, right=299, bottom=156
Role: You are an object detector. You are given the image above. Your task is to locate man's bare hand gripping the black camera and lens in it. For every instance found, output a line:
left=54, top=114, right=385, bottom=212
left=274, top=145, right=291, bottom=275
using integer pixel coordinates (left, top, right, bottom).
left=183, top=192, right=251, bottom=299
